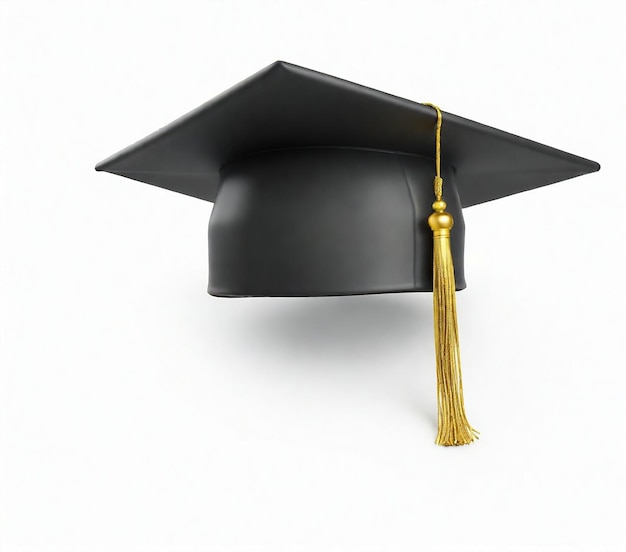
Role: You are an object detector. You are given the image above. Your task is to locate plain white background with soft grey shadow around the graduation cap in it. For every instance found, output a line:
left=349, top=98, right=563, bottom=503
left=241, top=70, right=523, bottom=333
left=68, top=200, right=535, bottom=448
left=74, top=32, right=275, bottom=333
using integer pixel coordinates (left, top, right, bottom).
left=0, top=0, right=626, bottom=552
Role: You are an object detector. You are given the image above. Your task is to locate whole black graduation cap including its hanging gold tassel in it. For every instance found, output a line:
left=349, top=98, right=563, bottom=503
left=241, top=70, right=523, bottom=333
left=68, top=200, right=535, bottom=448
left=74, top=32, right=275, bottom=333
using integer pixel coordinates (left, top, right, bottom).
left=96, top=61, right=600, bottom=445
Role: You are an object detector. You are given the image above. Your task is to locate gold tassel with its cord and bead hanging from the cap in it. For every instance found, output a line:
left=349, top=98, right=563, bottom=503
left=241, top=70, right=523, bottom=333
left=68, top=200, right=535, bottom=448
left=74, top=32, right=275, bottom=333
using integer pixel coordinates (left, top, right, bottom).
left=424, top=103, right=478, bottom=446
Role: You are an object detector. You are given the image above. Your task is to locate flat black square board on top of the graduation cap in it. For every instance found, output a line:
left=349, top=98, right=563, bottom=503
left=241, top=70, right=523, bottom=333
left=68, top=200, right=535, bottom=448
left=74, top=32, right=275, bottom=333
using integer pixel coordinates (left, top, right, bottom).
left=96, top=61, right=600, bottom=207
